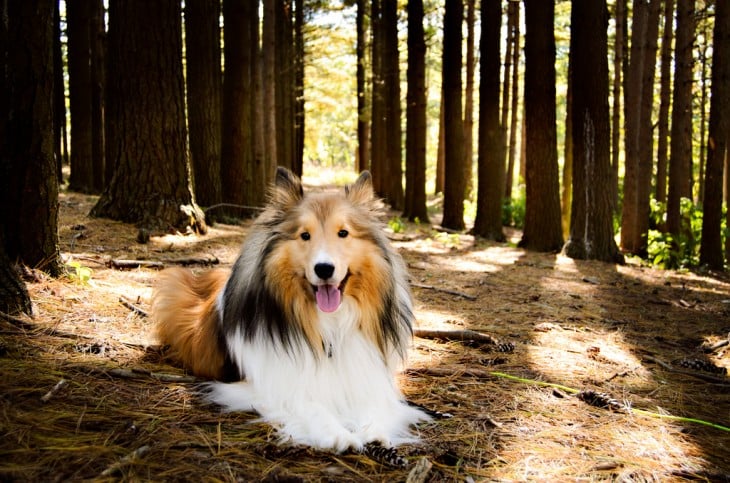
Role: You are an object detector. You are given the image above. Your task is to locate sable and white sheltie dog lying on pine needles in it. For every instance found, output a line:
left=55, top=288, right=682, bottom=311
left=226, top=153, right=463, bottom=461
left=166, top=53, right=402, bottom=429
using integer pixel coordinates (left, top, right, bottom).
left=152, top=168, right=428, bottom=452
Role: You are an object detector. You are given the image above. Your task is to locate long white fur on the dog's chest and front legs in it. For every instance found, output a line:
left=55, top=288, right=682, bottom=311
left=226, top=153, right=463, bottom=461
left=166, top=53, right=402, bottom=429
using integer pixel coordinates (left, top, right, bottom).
left=203, top=299, right=428, bottom=452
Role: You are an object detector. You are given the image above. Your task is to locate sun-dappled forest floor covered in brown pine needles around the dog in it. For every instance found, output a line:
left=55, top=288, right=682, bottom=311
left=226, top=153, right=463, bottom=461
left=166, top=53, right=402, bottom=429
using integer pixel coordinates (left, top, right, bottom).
left=0, top=182, right=730, bottom=482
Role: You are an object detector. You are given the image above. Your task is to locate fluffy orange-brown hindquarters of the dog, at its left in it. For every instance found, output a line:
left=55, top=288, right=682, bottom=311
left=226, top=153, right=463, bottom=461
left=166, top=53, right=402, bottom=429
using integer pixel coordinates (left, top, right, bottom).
left=152, top=268, right=228, bottom=380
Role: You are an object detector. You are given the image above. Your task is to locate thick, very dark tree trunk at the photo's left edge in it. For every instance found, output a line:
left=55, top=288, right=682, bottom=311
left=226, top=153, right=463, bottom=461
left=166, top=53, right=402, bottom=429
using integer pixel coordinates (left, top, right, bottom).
left=0, top=0, right=63, bottom=276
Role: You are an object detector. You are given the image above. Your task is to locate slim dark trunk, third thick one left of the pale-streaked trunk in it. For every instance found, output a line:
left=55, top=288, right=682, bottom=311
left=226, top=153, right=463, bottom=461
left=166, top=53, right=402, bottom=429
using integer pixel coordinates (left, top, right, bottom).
left=441, top=0, right=466, bottom=230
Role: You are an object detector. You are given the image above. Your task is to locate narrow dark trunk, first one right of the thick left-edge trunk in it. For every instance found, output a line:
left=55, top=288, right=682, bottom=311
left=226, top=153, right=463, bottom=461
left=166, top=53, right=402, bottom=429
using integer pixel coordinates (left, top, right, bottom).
left=66, top=1, right=95, bottom=193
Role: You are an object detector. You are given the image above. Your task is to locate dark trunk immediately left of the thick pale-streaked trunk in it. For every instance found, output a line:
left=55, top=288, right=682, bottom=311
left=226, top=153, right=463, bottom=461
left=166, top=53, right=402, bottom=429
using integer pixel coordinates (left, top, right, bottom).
left=520, top=0, right=563, bottom=252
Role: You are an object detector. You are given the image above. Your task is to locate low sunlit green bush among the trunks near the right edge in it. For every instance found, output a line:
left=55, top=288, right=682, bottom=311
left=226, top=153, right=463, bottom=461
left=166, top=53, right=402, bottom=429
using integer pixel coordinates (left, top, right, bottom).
left=647, top=198, right=702, bottom=268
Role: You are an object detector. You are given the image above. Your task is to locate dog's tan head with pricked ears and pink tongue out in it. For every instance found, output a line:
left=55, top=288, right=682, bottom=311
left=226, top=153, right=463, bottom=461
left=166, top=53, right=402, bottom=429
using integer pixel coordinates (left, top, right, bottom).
left=268, top=168, right=388, bottom=312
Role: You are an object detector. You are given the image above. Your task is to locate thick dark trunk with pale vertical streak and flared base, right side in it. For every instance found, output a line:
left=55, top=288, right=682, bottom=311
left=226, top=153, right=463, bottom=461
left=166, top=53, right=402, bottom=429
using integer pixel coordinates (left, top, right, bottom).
left=564, top=0, right=623, bottom=263
